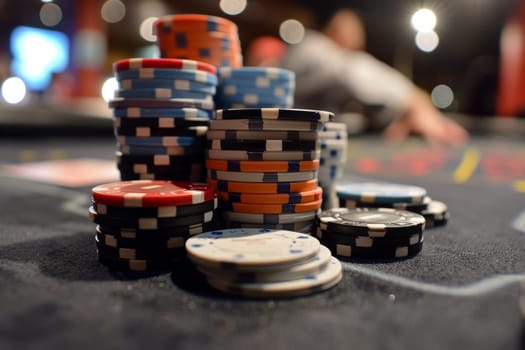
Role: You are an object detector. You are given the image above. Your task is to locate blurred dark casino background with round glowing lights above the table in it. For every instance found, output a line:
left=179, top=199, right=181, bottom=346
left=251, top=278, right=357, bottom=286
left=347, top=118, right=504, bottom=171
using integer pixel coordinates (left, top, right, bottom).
left=0, top=0, right=525, bottom=123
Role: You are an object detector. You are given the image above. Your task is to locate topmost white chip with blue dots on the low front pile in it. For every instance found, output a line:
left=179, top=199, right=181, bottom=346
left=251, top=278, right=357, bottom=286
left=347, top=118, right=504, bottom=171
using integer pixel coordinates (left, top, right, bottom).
left=186, top=228, right=320, bottom=269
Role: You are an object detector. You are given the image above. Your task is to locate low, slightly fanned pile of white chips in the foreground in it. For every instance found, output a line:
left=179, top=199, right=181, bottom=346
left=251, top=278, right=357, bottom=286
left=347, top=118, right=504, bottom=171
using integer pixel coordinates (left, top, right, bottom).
left=186, top=228, right=342, bottom=298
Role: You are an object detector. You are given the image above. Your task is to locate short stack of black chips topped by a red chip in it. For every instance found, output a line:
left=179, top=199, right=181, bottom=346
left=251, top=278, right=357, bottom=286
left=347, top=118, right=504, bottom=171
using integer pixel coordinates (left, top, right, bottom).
left=89, top=180, right=217, bottom=271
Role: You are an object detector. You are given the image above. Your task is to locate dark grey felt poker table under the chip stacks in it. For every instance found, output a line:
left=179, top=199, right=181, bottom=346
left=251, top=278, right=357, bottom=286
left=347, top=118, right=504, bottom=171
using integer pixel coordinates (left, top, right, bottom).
left=0, top=111, right=525, bottom=349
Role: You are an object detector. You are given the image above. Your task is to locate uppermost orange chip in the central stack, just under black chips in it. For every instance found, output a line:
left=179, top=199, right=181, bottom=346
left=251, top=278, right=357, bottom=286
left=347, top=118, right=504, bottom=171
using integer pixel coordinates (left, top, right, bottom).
left=206, top=159, right=320, bottom=173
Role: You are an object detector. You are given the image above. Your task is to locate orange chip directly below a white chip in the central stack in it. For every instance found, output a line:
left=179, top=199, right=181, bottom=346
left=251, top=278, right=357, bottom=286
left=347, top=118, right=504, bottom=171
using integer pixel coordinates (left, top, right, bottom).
left=208, top=179, right=317, bottom=193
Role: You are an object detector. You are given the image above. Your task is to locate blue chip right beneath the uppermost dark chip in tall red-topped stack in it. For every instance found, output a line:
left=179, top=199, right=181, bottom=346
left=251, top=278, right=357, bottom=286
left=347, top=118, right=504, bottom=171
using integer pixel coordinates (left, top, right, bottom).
left=113, top=107, right=214, bottom=119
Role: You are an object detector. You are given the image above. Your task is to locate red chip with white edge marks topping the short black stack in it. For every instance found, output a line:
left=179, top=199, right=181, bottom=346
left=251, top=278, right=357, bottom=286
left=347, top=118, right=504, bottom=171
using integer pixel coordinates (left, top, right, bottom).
left=91, top=180, right=216, bottom=208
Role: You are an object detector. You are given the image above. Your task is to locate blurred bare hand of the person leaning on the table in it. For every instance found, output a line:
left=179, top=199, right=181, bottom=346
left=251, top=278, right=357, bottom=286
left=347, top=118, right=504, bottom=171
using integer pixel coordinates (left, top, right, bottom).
left=383, top=91, right=468, bottom=146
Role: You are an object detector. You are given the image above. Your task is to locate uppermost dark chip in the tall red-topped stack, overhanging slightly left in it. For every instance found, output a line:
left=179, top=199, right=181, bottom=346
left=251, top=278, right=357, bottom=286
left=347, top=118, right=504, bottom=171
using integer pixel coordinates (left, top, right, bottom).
left=109, top=98, right=215, bottom=111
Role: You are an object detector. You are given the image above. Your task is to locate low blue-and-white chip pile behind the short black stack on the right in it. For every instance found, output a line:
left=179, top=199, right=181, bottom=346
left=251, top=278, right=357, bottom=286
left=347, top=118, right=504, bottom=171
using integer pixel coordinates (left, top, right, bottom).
left=336, top=182, right=450, bottom=228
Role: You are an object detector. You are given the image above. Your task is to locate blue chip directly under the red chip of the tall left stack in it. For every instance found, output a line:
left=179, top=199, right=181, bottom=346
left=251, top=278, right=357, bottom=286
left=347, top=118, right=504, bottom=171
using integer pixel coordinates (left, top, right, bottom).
left=115, top=68, right=218, bottom=85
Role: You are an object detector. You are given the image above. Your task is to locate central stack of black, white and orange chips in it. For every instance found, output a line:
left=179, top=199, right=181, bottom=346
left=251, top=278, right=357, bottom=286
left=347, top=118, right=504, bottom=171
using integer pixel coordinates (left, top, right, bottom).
left=206, top=108, right=333, bottom=232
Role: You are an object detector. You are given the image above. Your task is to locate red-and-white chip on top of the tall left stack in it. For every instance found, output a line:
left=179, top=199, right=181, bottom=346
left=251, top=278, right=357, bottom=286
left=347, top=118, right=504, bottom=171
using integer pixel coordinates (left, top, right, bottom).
left=113, top=58, right=217, bottom=74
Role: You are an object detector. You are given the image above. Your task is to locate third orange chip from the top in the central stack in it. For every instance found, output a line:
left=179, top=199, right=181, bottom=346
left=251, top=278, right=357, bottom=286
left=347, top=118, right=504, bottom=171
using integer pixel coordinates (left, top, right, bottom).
left=217, top=187, right=323, bottom=204
